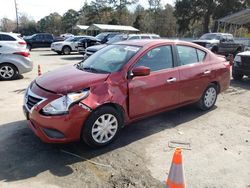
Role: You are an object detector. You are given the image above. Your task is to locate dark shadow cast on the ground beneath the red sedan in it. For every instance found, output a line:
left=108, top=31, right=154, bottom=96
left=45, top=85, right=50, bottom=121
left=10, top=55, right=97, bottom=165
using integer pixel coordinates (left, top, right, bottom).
left=0, top=106, right=216, bottom=182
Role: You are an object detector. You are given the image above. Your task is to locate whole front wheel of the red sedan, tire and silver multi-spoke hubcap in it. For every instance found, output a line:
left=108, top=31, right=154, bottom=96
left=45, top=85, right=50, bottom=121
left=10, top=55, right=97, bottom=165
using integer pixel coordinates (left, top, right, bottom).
left=81, top=106, right=123, bottom=148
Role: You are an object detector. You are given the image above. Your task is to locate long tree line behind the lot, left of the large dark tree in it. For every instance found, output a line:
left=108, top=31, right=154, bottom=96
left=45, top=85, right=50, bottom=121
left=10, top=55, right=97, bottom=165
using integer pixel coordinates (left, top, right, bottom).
left=2, top=0, right=176, bottom=37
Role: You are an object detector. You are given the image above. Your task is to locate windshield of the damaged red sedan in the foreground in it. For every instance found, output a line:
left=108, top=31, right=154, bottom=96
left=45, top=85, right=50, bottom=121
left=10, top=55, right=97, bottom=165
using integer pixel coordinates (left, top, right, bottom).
left=77, top=45, right=140, bottom=73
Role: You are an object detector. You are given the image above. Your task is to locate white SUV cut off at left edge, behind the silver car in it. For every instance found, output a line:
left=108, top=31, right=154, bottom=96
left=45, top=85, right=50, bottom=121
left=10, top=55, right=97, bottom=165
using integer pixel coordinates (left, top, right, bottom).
left=0, top=32, right=27, bottom=50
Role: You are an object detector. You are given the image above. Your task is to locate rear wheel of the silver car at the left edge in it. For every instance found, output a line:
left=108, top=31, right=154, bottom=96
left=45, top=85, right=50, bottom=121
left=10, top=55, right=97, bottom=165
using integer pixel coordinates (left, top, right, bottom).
left=0, top=63, right=19, bottom=80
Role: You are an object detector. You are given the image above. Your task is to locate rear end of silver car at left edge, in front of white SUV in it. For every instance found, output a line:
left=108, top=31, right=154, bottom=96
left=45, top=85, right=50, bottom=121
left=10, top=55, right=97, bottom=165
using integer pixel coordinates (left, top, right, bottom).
left=0, top=44, right=33, bottom=80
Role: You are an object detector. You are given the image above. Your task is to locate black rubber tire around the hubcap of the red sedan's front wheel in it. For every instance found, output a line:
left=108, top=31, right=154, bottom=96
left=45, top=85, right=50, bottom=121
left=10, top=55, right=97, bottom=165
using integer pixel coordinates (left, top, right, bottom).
left=81, top=106, right=123, bottom=148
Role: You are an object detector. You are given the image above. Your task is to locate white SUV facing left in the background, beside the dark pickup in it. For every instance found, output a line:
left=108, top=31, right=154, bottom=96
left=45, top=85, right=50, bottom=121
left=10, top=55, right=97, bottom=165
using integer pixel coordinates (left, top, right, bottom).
left=51, top=36, right=84, bottom=55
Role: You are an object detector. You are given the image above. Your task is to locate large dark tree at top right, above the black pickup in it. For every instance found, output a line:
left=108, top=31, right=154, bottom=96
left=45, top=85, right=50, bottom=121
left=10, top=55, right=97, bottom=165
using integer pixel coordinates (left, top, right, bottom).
left=175, top=0, right=250, bottom=34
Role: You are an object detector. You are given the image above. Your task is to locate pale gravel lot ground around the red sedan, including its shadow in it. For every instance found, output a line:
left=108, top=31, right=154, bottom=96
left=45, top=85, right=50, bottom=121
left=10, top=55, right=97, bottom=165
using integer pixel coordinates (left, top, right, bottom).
left=0, top=49, right=250, bottom=188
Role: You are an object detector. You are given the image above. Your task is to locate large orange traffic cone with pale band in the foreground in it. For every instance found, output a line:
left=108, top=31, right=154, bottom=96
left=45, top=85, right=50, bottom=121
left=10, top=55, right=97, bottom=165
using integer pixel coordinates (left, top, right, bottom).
left=166, top=148, right=185, bottom=188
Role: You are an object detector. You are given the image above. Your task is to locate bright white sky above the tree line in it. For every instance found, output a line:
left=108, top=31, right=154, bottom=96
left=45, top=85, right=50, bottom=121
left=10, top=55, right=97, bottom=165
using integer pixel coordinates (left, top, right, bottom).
left=0, top=0, right=174, bottom=21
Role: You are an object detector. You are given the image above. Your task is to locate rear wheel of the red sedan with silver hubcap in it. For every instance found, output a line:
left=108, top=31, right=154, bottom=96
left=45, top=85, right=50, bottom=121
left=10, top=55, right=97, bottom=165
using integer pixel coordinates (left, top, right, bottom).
left=198, top=83, right=218, bottom=111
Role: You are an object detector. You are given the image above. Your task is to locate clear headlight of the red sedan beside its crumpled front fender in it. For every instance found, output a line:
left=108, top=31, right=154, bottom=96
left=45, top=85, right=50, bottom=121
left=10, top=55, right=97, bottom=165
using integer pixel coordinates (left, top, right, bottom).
left=42, top=89, right=89, bottom=115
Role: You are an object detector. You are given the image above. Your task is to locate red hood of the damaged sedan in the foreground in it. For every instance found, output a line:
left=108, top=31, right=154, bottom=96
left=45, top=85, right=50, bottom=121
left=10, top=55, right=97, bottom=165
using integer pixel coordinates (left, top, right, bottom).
left=36, top=65, right=109, bottom=94
